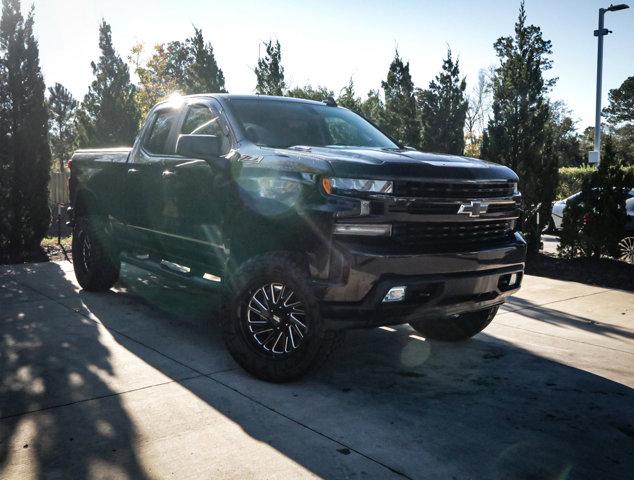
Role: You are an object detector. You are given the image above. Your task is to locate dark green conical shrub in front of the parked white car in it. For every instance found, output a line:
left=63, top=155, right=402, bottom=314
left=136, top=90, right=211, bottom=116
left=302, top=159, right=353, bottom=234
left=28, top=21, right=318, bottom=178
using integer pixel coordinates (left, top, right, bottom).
left=559, top=141, right=632, bottom=258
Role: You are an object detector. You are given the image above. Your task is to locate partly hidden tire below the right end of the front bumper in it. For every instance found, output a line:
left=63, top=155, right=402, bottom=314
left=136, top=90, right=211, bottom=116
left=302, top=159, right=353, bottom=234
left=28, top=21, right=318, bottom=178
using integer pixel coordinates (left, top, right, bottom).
left=410, top=307, right=498, bottom=342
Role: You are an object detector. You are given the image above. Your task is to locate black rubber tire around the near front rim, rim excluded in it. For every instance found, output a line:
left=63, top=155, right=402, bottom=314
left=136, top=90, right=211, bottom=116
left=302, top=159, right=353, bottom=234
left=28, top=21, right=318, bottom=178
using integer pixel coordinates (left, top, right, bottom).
left=221, top=253, right=343, bottom=382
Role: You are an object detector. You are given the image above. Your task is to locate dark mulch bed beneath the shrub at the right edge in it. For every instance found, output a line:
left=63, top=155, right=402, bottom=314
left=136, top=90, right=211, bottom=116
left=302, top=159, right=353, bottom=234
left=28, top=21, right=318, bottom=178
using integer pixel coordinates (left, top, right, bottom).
left=526, top=253, right=634, bottom=292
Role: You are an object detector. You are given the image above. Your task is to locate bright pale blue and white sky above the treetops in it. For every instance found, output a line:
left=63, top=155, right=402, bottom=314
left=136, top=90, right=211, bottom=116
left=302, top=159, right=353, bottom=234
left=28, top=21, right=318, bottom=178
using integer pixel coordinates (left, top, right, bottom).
left=30, top=0, right=634, bottom=128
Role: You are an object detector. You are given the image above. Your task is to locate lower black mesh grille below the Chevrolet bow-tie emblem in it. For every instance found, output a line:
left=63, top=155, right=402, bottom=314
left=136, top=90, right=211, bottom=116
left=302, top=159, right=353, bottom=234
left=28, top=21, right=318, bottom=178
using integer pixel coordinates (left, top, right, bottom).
left=392, top=220, right=515, bottom=251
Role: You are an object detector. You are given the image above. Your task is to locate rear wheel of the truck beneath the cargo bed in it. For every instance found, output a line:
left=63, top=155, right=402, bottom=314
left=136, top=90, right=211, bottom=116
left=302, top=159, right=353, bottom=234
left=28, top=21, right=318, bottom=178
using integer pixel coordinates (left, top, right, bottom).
left=72, top=215, right=121, bottom=292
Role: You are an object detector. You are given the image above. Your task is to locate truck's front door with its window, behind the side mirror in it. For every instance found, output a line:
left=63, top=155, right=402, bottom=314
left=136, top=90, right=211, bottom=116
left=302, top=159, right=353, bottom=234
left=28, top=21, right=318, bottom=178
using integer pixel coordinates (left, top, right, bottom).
left=162, top=99, right=233, bottom=276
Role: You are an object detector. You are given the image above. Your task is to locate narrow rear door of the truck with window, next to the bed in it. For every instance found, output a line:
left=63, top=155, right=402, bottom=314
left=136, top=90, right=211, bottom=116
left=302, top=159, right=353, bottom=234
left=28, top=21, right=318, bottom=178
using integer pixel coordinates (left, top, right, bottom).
left=125, top=106, right=180, bottom=254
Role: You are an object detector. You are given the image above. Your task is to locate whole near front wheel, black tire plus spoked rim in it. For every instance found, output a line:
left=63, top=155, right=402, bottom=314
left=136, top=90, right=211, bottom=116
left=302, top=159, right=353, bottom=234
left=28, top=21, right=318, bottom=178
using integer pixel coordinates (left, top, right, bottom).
left=222, top=254, right=341, bottom=382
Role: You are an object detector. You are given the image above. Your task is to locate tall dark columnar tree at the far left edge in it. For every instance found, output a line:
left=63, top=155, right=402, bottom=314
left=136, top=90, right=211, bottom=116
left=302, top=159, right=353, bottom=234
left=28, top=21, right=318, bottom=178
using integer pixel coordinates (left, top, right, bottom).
left=0, top=0, right=51, bottom=252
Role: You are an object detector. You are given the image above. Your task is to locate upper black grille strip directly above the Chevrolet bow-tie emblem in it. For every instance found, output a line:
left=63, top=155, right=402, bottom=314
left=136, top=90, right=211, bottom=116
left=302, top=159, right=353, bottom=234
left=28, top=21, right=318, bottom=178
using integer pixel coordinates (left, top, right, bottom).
left=393, top=181, right=515, bottom=200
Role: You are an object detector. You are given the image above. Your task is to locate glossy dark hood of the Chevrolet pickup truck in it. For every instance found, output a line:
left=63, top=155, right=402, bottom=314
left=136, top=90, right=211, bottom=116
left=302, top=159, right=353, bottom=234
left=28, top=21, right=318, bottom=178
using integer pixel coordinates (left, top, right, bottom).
left=270, top=147, right=517, bottom=181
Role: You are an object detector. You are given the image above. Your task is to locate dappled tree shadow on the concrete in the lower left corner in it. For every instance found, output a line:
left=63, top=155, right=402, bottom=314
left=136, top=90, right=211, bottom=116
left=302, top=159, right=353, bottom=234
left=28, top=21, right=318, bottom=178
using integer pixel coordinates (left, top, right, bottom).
left=0, top=264, right=146, bottom=479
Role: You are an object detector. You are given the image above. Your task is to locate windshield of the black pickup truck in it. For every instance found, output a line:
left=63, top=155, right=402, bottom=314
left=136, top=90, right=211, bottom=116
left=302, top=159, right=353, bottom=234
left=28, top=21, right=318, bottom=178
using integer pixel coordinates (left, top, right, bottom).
left=229, top=98, right=399, bottom=149
